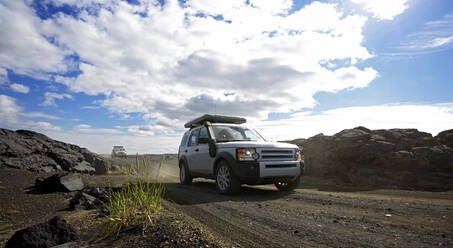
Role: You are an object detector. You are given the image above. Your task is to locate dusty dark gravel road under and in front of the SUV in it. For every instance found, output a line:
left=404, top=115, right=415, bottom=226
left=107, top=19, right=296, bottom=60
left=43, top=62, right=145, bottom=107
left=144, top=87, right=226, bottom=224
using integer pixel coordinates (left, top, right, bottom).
left=157, top=161, right=453, bottom=247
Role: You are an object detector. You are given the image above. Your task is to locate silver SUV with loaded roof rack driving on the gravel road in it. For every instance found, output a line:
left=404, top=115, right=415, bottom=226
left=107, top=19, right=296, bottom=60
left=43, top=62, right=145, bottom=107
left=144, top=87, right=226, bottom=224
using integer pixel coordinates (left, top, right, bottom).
left=178, top=115, right=304, bottom=194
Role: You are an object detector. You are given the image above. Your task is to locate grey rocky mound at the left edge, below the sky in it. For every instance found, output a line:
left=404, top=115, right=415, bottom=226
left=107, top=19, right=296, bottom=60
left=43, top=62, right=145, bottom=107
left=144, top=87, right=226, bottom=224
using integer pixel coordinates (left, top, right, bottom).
left=0, top=129, right=106, bottom=173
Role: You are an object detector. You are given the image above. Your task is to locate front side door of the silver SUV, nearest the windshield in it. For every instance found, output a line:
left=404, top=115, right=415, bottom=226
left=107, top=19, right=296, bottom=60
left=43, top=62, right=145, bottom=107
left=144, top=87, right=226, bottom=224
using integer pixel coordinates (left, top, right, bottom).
left=197, top=127, right=214, bottom=175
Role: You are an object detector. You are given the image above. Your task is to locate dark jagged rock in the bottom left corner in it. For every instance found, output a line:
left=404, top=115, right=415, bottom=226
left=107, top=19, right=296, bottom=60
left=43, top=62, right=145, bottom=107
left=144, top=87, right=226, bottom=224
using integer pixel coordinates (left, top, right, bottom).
left=5, top=216, right=80, bottom=248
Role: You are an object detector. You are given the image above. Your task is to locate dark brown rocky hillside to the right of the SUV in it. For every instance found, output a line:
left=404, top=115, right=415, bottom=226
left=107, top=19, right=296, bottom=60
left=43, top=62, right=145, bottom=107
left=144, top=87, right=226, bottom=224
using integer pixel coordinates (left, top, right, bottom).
left=290, top=127, right=453, bottom=190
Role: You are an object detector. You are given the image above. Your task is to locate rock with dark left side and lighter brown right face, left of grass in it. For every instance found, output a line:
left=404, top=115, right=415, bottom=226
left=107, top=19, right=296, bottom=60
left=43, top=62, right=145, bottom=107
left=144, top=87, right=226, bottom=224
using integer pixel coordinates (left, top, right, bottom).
left=34, top=173, right=84, bottom=192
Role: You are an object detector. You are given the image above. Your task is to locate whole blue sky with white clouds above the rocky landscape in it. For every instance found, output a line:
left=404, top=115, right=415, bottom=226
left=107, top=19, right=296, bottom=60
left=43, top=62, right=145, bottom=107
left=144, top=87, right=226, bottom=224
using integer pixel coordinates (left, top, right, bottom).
left=0, top=0, right=453, bottom=154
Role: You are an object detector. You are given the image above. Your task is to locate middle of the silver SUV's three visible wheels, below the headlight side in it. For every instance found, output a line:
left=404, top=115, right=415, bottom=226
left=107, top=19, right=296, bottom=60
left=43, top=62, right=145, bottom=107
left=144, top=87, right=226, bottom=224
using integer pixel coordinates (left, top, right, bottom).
left=215, top=160, right=241, bottom=195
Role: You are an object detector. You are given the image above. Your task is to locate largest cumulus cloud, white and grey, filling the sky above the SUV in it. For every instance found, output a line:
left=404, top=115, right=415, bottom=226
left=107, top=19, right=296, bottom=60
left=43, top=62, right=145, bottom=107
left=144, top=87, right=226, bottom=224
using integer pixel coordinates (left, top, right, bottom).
left=5, top=0, right=378, bottom=126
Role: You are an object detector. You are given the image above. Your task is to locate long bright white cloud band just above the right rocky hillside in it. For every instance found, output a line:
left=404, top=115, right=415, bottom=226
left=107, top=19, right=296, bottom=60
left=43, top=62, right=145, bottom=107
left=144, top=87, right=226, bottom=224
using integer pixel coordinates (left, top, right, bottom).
left=256, top=103, right=453, bottom=140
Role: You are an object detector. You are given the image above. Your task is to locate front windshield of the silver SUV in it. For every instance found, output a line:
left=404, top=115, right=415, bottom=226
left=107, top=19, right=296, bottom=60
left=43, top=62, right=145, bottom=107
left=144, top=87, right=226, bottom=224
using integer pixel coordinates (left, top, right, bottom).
left=212, top=125, right=264, bottom=142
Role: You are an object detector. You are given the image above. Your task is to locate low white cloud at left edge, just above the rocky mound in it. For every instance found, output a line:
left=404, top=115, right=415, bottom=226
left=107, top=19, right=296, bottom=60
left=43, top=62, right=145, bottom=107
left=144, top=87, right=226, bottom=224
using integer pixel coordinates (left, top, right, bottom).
left=0, top=94, right=61, bottom=131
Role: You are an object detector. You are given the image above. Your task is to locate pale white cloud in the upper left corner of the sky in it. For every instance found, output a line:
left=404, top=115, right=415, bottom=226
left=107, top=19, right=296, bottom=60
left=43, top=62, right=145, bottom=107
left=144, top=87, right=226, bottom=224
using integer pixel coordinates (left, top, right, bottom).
left=0, top=0, right=68, bottom=77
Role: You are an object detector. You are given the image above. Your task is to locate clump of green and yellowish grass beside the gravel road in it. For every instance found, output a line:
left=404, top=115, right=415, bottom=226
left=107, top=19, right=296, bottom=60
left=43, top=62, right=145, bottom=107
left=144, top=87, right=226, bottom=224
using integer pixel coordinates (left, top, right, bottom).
left=105, top=155, right=165, bottom=233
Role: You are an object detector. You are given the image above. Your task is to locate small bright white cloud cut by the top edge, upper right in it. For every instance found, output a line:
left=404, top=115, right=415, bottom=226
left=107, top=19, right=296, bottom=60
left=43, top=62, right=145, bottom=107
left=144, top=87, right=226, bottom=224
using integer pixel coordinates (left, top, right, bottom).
left=351, top=0, right=409, bottom=20
